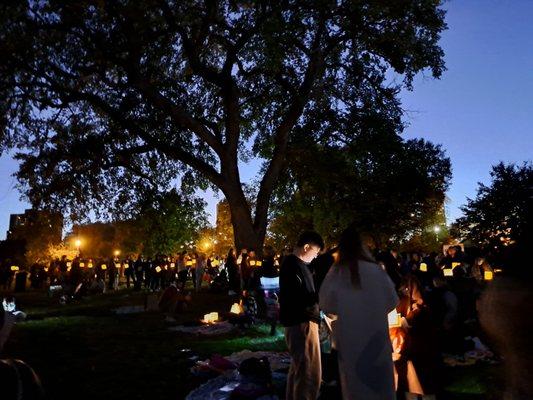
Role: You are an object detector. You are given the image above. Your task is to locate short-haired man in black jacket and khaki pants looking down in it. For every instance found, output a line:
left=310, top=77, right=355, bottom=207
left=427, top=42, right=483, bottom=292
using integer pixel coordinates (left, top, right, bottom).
left=279, top=232, right=324, bottom=400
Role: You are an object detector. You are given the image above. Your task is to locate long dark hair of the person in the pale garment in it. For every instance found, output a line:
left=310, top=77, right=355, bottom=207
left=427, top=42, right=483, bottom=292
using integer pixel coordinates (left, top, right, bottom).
left=337, top=224, right=375, bottom=289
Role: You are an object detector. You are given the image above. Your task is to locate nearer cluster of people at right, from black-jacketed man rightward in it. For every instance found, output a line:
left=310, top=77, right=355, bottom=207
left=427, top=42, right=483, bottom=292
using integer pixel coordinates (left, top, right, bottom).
left=280, top=227, right=494, bottom=400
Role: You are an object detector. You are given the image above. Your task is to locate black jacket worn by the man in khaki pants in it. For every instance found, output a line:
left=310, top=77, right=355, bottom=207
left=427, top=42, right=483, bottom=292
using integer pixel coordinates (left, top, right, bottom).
left=279, top=254, right=320, bottom=326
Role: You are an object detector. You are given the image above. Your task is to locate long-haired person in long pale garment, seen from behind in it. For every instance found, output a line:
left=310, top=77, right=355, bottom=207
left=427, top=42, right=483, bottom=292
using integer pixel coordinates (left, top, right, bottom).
left=319, top=226, right=398, bottom=400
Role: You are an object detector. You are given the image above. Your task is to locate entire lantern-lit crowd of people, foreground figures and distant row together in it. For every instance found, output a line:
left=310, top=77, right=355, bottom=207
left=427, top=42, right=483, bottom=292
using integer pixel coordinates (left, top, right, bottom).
left=0, top=228, right=494, bottom=400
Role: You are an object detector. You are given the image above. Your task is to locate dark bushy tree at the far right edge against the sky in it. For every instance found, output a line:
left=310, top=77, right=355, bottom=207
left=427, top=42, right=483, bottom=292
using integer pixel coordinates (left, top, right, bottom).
left=453, top=163, right=533, bottom=262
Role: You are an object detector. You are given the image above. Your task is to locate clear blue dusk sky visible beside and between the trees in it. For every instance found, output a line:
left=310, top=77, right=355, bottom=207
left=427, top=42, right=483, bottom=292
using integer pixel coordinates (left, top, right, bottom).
left=0, top=0, right=533, bottom=239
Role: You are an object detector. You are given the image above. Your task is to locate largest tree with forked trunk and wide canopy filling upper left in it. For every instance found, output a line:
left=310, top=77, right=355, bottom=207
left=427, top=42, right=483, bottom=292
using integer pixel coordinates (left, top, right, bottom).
left=0, top=0, right=445, bottom=248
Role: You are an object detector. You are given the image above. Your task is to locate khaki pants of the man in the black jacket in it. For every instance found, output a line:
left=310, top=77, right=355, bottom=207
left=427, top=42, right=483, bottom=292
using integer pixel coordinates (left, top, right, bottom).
left=285, top=321, right=322, bottom=400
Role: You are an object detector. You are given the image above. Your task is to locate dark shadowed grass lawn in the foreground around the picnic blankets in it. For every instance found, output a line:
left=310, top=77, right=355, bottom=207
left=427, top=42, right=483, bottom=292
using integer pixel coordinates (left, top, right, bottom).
left=3, top=290, right=501, bottom=400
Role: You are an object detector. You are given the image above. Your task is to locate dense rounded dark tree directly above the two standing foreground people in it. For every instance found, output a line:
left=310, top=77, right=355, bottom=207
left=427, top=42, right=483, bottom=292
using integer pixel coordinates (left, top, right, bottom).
left=271, top=132, right=451, bottom=249
